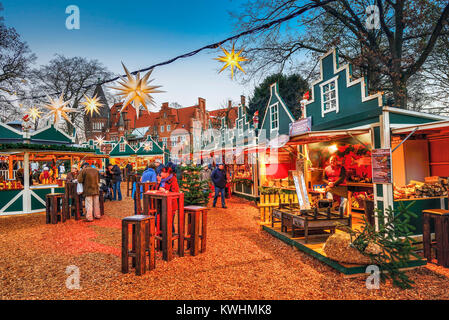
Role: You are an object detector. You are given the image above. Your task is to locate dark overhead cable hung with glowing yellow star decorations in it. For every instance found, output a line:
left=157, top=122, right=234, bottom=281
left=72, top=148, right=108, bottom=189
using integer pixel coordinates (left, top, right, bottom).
left=3, top=0, right=335, bottom=131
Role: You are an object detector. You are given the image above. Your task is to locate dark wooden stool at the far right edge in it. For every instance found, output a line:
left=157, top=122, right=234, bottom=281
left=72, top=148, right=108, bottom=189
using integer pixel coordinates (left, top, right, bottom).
left=422, top=209, right=449, bottom=268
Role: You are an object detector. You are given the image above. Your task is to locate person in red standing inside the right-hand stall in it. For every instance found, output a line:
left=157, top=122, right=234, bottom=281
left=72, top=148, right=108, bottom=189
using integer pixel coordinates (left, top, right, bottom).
left=323, top=156, right=348, bottom=208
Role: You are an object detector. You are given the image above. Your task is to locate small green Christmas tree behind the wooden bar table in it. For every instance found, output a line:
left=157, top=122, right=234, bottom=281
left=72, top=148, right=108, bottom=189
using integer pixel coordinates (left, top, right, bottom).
left=179, top=165, right=210, bottom=206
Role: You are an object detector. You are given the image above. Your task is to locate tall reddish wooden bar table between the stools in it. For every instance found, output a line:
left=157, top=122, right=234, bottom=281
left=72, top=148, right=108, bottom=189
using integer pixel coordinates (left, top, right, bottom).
left=143, top=190, right=185, bottom=261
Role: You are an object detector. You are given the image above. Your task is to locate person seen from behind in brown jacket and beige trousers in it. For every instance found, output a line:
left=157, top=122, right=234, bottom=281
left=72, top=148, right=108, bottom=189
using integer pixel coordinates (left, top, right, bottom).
left=78, top=161, right=101, bottom=222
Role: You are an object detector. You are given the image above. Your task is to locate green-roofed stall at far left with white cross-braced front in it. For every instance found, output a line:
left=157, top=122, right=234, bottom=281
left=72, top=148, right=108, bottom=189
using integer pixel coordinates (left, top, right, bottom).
left=0, top=123, right=105, bottom=215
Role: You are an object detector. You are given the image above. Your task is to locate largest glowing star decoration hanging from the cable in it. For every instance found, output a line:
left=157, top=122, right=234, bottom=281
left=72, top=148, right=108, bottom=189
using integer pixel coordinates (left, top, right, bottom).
left=111, top=63, right=164, bottom=118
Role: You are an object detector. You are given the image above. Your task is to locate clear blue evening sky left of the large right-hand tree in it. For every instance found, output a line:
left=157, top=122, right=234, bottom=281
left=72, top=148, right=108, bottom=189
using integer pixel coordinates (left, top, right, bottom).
left=0, top=0, right=253, bottom=110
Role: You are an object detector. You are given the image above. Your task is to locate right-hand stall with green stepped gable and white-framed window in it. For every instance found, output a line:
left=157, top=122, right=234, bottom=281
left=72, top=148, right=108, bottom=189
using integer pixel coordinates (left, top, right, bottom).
left=259, top=49, right=449, bottom=274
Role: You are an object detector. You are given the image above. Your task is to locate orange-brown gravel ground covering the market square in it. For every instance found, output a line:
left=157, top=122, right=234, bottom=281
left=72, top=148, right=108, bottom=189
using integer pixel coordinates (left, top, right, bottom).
left=0, top=189, right=449, bottom=299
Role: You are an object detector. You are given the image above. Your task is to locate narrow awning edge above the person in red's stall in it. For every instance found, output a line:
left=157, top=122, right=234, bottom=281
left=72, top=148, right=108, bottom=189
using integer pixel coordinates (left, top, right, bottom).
left=287, top=129, right=370, bottom=145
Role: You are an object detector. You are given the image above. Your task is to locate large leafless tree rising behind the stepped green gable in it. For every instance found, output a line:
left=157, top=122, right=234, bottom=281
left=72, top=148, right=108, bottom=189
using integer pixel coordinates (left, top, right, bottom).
left=233, top=0, right=449, bottom=108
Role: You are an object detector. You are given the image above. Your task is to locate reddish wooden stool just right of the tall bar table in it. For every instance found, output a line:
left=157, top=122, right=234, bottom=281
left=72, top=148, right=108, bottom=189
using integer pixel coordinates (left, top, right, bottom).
left=184, top=206, right=209, bottom=256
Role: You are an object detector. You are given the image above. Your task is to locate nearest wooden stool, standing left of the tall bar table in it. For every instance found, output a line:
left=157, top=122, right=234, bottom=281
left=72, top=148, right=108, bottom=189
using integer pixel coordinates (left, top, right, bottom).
left=122, top=215, right=156, bottom=276
